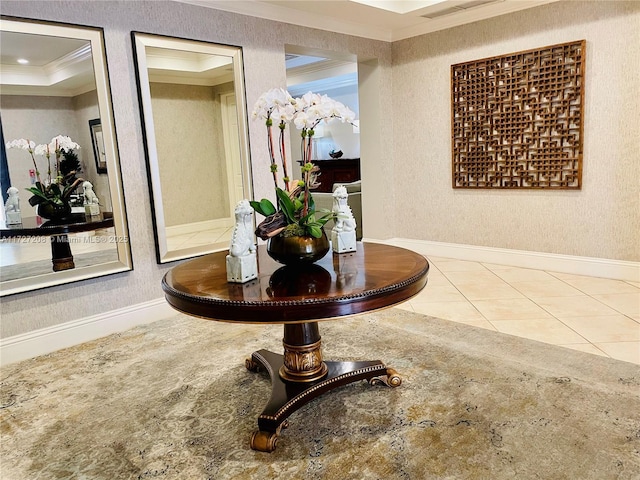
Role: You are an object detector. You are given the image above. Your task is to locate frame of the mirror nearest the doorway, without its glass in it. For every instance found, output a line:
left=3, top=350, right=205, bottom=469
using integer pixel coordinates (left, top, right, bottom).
left=131, top=31, right=253, bottom=264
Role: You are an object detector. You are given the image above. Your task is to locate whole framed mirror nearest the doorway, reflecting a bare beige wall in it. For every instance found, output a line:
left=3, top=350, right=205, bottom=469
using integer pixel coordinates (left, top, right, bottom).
left=132, top=32, right=252, bottom=263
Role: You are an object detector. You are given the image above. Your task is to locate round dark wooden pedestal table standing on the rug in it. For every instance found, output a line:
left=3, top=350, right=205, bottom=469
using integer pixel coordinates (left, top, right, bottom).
left=162, top=243, right=429, bottom=452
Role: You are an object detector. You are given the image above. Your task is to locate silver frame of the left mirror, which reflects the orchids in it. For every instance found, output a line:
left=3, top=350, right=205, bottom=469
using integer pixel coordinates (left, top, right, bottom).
left=0, top=15, right=133, bottom=297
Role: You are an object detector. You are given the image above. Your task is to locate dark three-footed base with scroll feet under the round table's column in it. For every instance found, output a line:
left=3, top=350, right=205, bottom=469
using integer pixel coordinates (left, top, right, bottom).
left=246, top=350, right=402, bottom=452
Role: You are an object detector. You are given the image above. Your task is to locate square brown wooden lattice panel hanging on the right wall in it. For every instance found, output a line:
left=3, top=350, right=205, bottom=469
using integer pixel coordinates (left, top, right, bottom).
left=451, top=40, right=586, bottom=189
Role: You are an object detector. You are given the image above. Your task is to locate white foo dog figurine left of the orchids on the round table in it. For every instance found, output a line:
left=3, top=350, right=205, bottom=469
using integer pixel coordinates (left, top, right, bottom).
left=227, top=200, right=258, bottom=283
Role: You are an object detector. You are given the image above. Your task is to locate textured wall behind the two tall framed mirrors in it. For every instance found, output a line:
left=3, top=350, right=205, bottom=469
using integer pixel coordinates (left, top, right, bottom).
left=0, top=0, right=391, bottom=338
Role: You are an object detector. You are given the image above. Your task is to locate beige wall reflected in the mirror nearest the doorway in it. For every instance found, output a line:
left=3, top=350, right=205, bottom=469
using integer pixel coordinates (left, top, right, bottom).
left=151, top=83, right=229, bottom=227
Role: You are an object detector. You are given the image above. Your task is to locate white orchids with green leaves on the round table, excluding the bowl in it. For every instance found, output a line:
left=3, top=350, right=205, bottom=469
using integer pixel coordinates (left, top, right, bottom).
left=250, top=88, right=355, bottom=240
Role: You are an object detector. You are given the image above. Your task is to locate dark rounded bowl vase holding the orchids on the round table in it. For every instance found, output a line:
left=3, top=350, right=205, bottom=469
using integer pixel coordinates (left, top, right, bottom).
left=267, top=229, right=330, bottom=265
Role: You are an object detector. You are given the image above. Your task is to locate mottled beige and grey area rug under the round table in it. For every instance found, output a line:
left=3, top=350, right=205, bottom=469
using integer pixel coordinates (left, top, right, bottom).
left=0, top=309, right=640, bottom=480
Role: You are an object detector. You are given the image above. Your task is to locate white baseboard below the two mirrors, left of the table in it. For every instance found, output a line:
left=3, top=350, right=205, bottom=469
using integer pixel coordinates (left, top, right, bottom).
left=0, top=298, right=176, bottom=365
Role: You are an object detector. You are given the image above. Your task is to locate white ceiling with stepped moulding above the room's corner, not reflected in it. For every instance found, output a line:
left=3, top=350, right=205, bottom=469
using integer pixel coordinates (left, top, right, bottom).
left=174, top=0, right=558, bottom=42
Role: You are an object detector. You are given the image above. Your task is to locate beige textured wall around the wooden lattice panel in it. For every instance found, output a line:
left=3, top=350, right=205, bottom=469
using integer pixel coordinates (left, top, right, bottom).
left=390, top=2, right=640, bottom=261
